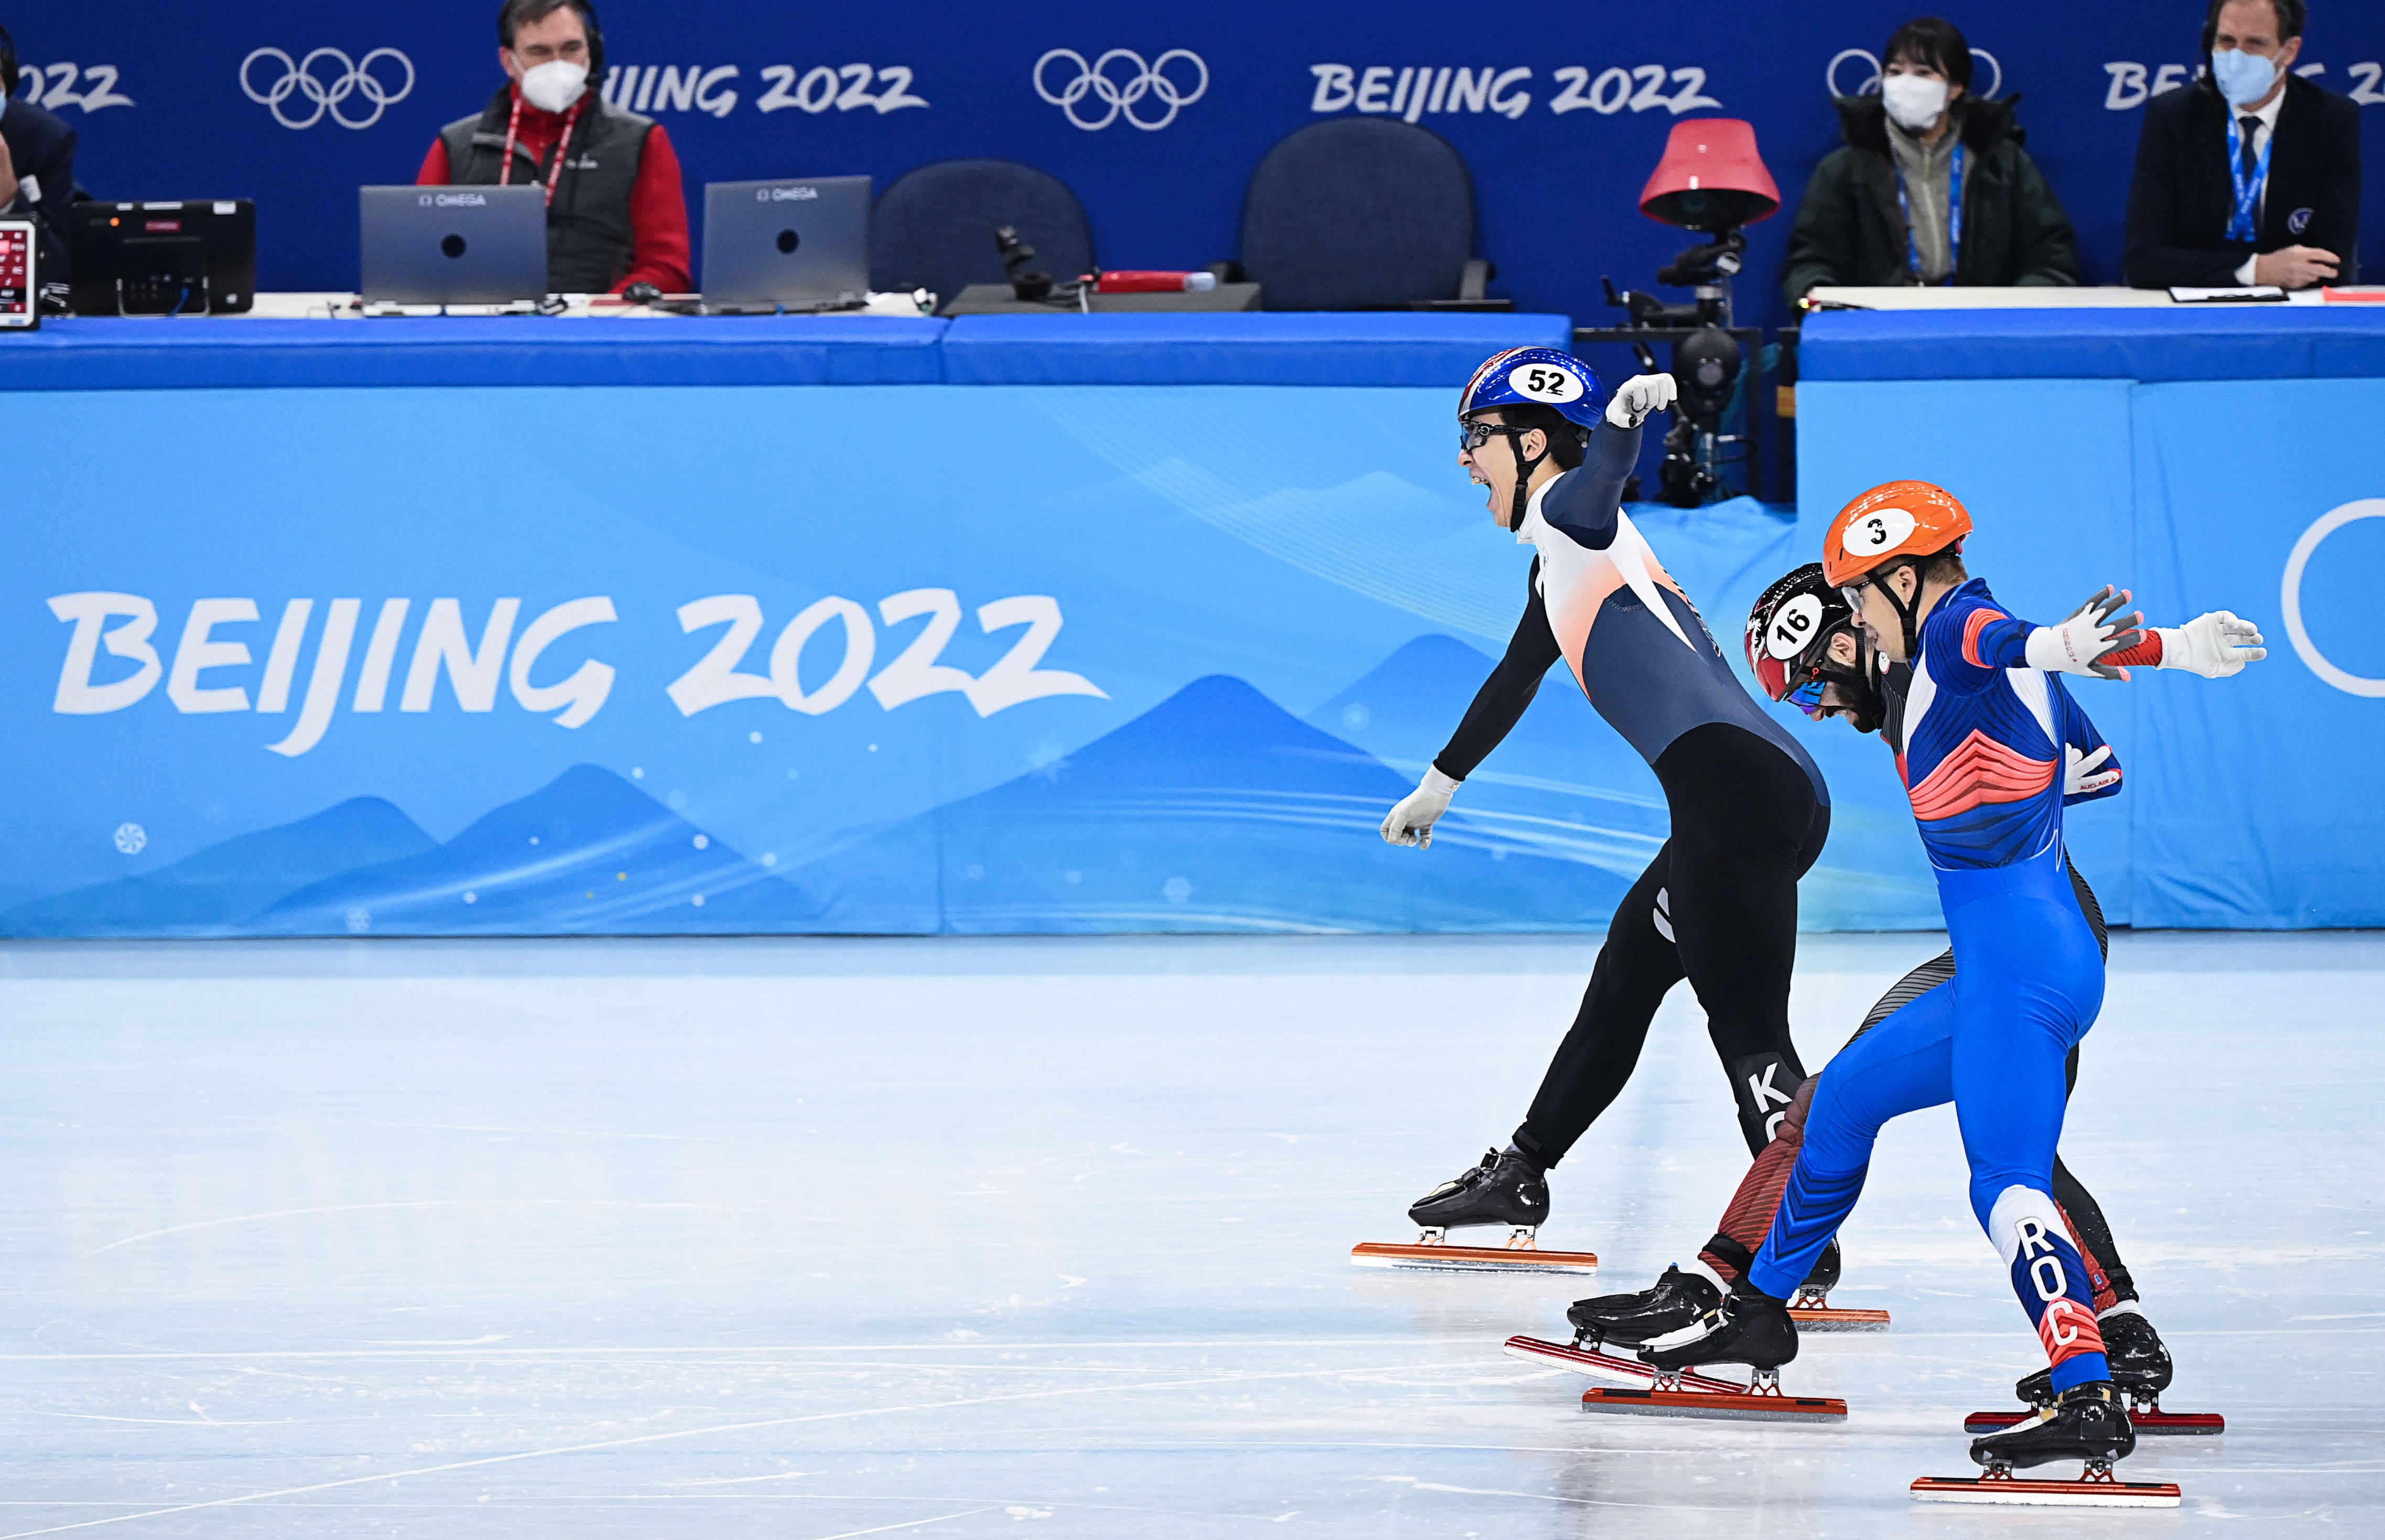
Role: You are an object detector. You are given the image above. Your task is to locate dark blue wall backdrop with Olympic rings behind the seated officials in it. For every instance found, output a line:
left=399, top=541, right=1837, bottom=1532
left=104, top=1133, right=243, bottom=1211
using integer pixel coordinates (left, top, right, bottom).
left=9, top=0, right=2385, bottom=322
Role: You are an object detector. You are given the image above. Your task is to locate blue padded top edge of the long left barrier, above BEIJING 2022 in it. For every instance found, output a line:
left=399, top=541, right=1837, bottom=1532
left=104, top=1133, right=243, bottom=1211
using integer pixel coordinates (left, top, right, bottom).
left=0, top=312, right=1571, bottom=391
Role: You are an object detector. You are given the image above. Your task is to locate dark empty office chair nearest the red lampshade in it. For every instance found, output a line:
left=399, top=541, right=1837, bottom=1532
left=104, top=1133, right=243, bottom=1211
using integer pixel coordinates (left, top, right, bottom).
left=1240, top=117, right=1510, bottom=310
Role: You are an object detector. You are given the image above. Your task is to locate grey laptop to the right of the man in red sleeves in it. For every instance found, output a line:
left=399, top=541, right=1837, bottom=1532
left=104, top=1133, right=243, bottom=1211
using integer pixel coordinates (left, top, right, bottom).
left=703, top=177, right=871, bottom=314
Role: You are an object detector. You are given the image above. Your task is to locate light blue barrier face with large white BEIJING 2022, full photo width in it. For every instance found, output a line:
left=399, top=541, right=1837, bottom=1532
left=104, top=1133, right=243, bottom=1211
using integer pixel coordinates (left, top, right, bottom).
left=0, top=382, right=2385, bottom=935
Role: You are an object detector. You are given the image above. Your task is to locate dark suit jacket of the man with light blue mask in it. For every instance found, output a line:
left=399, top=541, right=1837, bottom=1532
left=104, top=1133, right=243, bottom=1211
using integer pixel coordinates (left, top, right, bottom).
left=2125, top=74, right=2361, bottom=288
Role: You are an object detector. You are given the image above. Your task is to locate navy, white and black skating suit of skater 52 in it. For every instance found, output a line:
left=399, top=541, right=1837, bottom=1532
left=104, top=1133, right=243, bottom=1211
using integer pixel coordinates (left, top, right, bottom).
left=1434, top=425, right=1829, bottom=1163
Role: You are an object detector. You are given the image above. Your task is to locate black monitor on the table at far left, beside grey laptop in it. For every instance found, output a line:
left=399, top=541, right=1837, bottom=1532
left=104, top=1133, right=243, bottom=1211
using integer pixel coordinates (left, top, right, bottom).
left=67, top=198, right=257, bottom=314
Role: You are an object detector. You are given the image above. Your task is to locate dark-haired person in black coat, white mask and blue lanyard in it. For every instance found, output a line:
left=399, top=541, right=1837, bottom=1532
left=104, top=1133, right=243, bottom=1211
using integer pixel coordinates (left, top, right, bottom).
left=1782, top=17, right=2080, bottom=305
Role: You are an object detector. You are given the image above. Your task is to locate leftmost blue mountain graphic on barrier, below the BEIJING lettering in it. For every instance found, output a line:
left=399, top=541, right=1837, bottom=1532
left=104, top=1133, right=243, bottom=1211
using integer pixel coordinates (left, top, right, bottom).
left=0, top=796, right=439, bottom=937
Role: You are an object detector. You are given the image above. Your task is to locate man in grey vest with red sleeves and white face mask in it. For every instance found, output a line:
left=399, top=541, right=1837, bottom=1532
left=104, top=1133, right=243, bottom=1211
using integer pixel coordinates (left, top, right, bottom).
left=415, top=0, right=694, bottom=293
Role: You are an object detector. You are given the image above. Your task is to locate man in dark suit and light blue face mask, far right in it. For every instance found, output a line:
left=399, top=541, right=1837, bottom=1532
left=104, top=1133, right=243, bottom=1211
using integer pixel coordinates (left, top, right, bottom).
left=2128, top=0, right=2361, bottom=288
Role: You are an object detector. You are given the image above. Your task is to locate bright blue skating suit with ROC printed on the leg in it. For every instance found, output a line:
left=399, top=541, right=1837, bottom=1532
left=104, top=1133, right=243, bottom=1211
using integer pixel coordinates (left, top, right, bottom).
left=1748, top=579, right=2116, bottom=1390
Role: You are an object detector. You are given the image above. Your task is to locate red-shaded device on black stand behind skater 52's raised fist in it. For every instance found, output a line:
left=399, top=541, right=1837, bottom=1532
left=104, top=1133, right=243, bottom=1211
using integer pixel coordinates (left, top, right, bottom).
left=1600, top=117, right=1782, bottom=508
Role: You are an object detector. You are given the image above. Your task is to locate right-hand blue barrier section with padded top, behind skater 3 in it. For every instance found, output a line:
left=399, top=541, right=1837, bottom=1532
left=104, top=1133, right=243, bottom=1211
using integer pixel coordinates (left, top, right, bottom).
left=1798, top=293, right=2385, bottom=927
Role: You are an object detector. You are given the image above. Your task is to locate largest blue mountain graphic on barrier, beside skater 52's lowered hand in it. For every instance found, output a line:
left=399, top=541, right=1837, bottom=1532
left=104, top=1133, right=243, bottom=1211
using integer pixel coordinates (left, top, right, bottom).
left=799, top=675, right=1627, bottom=935
